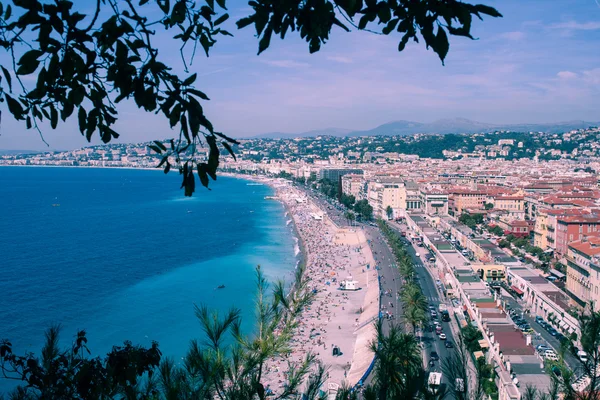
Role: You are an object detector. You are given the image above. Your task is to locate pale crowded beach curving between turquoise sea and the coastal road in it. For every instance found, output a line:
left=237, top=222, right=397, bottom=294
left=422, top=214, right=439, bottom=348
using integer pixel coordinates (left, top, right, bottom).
left=266, top=182, right=379, bottom=393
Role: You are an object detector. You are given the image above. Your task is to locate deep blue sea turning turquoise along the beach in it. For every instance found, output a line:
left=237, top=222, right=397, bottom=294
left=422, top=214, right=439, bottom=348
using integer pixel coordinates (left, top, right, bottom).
left=0, top=167, right=299, bottom=393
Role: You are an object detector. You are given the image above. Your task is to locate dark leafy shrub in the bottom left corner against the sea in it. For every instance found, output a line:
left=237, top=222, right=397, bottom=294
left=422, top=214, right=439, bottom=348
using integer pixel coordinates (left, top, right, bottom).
left=0, top=326, right=161, bottom=399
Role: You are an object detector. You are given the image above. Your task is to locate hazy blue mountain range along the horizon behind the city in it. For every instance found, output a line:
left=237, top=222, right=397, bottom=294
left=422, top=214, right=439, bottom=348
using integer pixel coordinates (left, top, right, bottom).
left=253, top=118, right=600, bottom=139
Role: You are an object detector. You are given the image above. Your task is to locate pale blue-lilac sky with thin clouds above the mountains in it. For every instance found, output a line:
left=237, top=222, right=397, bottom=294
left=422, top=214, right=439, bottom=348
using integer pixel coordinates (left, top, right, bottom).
left=0, top=0, right=600, bottom=150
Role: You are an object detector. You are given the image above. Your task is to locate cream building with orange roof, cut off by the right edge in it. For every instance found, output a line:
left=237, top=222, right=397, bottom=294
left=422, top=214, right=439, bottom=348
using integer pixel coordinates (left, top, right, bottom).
left=566, top=237, right=600, bottom=311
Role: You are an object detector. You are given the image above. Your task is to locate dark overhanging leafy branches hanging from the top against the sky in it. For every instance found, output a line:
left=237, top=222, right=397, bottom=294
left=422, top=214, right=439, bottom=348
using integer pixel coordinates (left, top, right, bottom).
left=0, top=0, right=501, bottom=196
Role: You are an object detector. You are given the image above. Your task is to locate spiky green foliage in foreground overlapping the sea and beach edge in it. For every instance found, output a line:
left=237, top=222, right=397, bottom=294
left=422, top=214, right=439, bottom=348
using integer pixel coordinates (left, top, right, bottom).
left=161, top=266, right=316, bottom=400
